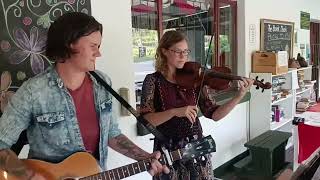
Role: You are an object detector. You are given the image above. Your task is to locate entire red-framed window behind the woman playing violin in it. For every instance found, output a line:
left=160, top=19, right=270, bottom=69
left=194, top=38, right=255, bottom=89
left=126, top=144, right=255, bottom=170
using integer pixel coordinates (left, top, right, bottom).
left=131, top=0, right=237, bottom=103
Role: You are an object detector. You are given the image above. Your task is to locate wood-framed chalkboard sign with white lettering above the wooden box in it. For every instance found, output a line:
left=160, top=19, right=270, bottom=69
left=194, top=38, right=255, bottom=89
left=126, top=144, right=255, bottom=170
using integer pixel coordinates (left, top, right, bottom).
left=260, top=19, right=294, bottom=58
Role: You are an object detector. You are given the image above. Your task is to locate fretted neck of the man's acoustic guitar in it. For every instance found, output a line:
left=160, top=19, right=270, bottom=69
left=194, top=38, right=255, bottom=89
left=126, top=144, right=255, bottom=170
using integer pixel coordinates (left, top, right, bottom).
left=80, top=149, right=182, bottom=180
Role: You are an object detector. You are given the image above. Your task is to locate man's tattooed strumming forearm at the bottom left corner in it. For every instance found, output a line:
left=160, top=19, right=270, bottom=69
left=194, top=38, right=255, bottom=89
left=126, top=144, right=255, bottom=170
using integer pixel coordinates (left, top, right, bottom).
left=0, top=149, right=28, bottom=177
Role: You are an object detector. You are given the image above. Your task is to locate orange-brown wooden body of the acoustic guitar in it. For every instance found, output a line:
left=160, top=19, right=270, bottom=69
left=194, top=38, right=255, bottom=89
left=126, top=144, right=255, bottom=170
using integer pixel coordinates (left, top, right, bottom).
left=0, top=152, right=100, bottom=180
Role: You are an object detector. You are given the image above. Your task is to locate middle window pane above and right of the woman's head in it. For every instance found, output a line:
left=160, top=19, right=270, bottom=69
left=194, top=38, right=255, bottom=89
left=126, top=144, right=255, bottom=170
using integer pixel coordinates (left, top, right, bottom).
left=163, top=0, right=213, bottom=64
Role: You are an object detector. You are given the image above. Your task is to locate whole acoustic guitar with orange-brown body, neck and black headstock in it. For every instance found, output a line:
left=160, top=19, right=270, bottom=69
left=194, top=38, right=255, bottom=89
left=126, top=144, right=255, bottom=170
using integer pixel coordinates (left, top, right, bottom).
left=0, top=136, right=216, bottom=180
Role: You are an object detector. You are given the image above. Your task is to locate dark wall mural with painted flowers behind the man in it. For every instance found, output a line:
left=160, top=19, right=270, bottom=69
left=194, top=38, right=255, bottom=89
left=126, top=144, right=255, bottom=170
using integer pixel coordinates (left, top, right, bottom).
left=0, top=0, right=91, bottom=112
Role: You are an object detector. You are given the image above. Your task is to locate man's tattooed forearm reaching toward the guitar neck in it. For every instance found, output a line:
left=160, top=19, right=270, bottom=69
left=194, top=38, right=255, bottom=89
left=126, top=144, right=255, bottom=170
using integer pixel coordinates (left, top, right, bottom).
left=109, top=134, right=150, bottom=160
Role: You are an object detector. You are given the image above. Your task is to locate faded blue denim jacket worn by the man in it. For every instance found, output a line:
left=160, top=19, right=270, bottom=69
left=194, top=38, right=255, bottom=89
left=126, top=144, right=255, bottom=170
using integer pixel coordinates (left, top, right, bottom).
left=0, top=66, right=121, bottom=169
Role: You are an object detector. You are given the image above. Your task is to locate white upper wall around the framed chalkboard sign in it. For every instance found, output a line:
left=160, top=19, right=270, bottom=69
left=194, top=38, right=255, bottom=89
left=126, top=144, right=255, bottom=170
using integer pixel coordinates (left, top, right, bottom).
left=238, top=0, right=320, bottom=75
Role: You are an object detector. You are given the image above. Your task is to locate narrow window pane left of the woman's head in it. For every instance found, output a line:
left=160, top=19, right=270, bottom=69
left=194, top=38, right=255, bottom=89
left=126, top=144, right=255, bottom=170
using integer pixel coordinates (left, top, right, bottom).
left=131, top=0, right=159, bottom=104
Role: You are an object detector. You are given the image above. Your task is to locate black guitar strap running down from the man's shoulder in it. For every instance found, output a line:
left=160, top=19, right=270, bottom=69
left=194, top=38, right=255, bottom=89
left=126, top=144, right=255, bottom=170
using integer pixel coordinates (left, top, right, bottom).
left=89, top=71, right=168, bottom=142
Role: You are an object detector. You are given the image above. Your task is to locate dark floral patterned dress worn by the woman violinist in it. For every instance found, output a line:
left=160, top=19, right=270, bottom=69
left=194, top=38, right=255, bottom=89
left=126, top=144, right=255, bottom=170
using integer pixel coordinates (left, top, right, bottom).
left=140, top=72, right=218, bottom=180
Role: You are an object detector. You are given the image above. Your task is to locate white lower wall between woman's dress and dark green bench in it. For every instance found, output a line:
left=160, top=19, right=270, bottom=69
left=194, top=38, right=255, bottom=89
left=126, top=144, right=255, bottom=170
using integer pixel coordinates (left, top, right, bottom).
left=200, top=102, right=249, bottom=168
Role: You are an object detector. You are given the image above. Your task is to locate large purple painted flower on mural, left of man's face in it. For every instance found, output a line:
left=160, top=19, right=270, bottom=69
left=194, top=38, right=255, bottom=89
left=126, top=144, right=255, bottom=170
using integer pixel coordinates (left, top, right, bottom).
left=9, top=27, right=46, bottom=74
